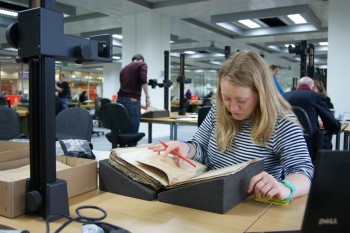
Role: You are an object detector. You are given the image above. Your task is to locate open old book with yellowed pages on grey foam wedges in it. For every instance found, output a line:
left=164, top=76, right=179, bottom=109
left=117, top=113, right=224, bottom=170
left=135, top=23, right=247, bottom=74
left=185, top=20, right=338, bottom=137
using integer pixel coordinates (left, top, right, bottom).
left=109, top=145, right=256, bottom=190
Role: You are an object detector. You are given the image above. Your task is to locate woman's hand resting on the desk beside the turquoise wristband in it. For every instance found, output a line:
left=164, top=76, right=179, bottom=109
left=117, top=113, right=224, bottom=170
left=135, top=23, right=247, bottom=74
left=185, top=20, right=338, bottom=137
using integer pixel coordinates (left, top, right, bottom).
left=248, top=172, right=291, bottom=200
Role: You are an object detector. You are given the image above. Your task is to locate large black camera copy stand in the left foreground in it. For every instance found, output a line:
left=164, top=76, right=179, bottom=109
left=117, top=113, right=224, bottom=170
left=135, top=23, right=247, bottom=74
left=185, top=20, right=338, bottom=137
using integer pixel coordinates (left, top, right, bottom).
left=6, top=0, right=112, bottom=221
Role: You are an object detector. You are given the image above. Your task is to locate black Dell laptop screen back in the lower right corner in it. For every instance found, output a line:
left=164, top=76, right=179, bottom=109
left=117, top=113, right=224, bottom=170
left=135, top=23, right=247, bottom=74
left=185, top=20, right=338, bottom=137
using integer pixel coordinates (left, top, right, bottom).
left=302, top=150, right=350, bottom=233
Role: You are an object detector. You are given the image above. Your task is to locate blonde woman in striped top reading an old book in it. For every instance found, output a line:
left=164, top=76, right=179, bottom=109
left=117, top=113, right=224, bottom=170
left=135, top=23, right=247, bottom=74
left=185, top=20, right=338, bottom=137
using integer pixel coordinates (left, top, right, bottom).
left=149, top=51, right=314, bottom=200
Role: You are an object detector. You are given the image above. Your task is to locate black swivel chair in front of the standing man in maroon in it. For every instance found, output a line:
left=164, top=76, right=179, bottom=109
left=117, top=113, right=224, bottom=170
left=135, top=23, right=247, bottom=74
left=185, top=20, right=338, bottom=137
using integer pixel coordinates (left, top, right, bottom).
left=102, top=103, right=145, bottom=148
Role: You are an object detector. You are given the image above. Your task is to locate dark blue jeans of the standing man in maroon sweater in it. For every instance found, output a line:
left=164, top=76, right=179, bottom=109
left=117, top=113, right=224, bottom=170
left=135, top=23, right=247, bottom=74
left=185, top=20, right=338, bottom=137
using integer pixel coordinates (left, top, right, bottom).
left=117, top=96, right=141, bottom=133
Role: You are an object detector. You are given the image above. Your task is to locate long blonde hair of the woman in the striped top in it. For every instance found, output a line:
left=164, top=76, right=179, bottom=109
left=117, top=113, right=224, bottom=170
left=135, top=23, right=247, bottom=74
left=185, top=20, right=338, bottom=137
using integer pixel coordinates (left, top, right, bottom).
left=215, top=51, right=292, bottom=152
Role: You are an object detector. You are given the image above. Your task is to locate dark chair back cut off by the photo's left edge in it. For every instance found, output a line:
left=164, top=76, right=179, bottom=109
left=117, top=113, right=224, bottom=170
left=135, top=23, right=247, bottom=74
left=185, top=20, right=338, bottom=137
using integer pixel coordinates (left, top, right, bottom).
left=0, top=107, right=25, bottom=140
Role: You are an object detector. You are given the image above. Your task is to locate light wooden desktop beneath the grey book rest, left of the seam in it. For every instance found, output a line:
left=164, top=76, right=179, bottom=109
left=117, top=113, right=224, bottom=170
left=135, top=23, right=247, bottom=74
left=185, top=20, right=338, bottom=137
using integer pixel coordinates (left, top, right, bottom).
left=0, top=190, right=274, bottom=233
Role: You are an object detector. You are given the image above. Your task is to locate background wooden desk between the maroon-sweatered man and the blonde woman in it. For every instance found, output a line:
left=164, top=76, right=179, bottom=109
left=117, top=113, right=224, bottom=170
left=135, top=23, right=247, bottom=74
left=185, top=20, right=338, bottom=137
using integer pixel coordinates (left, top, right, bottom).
left=141, top=115, right=198, bottom=143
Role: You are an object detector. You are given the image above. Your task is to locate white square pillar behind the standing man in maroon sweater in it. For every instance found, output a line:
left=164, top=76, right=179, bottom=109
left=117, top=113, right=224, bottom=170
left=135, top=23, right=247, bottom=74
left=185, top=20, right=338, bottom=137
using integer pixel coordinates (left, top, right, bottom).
left=122, top=12, right=170, bottom=138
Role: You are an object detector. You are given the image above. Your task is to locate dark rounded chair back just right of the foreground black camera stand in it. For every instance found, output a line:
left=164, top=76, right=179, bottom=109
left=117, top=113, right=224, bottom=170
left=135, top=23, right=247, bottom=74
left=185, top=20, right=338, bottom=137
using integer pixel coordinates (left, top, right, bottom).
left=56, top=108, right=93, bottom=142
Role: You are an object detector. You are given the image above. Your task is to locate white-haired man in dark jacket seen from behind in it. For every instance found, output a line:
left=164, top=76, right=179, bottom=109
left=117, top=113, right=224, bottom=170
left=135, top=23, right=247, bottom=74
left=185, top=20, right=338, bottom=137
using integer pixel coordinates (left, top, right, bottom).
left=283, top=77, right=340, bottom=160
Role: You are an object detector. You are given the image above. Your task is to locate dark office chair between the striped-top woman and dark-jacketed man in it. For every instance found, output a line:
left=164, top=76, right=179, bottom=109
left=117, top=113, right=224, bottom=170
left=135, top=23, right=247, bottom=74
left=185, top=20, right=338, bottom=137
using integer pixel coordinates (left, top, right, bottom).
left=292, top=106, right=325, bottom=161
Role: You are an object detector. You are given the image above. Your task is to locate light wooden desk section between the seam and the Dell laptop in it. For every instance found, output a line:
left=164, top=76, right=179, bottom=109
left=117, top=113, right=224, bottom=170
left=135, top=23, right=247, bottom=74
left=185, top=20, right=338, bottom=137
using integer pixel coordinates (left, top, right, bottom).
left=247, top=196, right=307, bottom=232
